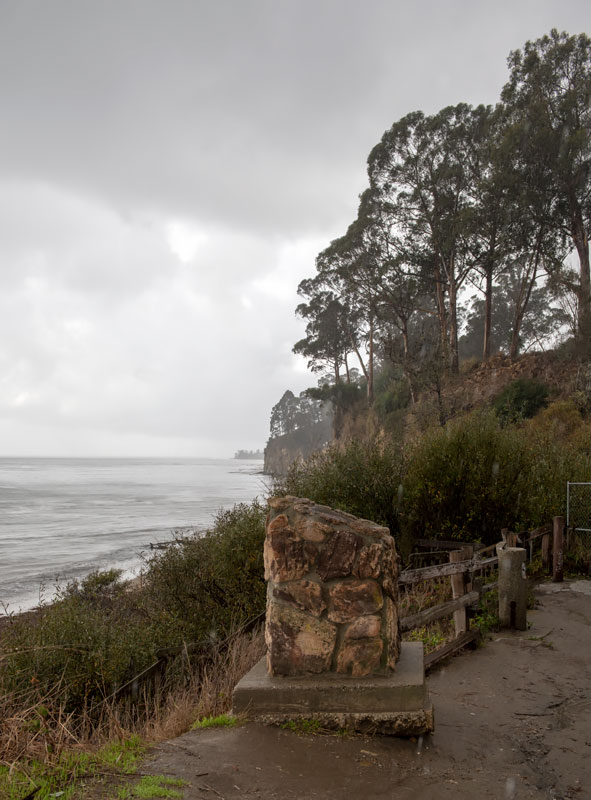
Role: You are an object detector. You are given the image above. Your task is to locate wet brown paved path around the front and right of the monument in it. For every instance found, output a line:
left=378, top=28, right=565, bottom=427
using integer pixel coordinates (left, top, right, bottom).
left=146, top=581, right=591, bottom=800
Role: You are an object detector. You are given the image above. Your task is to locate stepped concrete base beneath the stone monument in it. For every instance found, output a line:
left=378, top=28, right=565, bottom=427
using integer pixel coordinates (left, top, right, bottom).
left=232, top=642, right=433, bottom=736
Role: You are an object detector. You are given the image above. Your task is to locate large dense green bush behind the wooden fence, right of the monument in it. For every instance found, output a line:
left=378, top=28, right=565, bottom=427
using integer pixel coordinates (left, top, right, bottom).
left=401, top=410, right=591, bottom=544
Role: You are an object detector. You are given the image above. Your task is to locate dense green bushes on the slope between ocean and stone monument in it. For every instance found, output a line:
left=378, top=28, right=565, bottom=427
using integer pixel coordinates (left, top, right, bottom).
left=0, top=501, right=265, bottom=711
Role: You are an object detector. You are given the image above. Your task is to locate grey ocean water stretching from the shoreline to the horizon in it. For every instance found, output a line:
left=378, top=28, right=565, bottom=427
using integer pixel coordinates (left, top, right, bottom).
left=0, top=458, right=267, bottom=615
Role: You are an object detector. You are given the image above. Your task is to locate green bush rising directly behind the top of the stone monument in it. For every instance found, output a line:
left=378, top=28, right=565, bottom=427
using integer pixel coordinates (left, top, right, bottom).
left=273, top=434, right=402, bottom=532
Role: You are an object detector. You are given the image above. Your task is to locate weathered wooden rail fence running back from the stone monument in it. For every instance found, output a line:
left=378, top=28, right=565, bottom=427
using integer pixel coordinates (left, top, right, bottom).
left=398, top=517, right=568, bottom=669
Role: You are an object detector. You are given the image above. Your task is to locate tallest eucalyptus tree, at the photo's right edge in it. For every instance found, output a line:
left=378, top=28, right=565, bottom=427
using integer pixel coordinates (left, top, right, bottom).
left=502, top=29, right=591, bottom=342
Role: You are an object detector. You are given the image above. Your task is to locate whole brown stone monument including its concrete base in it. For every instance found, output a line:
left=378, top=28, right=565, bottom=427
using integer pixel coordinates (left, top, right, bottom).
left=233, top=497, right=433, bottom=735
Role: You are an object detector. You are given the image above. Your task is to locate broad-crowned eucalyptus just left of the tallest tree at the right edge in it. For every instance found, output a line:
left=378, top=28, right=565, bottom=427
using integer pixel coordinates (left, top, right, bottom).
left=368, top=103, right=481, bottom=372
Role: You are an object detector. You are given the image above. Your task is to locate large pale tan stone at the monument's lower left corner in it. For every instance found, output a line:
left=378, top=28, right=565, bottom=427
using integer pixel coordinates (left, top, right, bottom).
left=265, top=601, right=337, bottom=675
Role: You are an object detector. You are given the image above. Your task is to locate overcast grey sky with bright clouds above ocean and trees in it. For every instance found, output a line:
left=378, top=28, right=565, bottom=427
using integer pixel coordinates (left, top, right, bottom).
left=0, top=0, right=591, bottom=457
